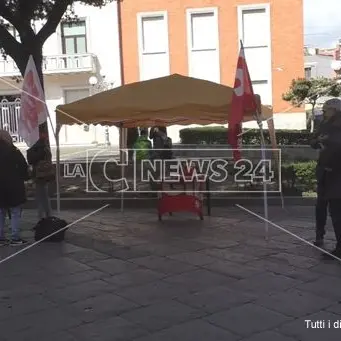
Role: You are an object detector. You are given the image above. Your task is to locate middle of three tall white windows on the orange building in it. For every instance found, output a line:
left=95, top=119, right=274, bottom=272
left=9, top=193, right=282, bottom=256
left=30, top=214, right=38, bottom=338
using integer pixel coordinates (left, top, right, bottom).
left=187, top=8, right=220, bottom=83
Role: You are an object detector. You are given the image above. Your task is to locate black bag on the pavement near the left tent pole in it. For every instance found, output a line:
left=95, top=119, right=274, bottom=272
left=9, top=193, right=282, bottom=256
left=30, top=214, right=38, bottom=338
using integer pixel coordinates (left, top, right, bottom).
left=33, top=217, right=68, bottom=242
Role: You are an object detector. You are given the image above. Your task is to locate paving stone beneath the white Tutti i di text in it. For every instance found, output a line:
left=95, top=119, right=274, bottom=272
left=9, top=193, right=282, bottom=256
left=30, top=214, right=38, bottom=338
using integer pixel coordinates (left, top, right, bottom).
left=279, top=311, right=341, bottom=341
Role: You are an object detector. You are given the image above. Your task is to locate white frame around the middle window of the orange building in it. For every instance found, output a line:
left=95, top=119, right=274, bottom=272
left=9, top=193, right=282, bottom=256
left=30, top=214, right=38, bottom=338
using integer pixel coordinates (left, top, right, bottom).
left=186, top=7, right=221, bottom=83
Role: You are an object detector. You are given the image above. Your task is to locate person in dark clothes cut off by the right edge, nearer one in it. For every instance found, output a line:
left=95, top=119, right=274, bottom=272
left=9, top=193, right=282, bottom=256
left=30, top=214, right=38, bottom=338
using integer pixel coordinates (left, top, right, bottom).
left=318, top=98, right=341, bottom=258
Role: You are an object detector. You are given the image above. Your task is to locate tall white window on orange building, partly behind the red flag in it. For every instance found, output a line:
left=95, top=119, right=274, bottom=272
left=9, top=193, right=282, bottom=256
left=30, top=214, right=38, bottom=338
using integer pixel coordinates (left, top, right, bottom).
left=238, top=5, right=272, bottom=105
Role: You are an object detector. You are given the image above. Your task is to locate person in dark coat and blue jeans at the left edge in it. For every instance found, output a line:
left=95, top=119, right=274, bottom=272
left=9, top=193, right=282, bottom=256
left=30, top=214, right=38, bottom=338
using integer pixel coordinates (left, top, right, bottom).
left=0, top=130, right=29, bottom=245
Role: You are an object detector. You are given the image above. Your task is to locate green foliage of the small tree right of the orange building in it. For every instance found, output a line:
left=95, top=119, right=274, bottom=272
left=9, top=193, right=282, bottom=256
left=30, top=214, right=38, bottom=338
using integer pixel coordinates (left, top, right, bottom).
left=283, top=77, right=341, bottom=108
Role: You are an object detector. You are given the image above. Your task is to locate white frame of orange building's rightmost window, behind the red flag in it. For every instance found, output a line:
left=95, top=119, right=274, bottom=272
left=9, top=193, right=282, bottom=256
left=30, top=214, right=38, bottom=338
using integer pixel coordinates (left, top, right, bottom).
left=237, top=3, right=273, bottom=105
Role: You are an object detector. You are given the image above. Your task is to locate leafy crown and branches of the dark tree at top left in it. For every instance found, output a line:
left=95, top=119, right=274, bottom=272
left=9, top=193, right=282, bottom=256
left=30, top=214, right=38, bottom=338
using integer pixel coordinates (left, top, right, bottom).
left=0, top=0, right=113, bottom=78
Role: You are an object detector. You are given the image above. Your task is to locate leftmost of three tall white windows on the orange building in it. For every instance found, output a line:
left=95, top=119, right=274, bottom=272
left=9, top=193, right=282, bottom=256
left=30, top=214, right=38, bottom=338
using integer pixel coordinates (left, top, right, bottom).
left=137, top=12, right=170, bottom=80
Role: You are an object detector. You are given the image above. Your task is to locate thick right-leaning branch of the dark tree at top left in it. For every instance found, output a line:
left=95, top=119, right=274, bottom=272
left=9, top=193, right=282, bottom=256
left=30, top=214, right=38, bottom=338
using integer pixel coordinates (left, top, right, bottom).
left=37, top=0, right=73, bottom=45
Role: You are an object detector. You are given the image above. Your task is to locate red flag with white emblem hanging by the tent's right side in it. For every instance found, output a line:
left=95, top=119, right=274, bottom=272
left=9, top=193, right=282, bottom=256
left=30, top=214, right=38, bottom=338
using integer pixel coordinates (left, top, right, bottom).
left=228, top=45, right=257, bottom=161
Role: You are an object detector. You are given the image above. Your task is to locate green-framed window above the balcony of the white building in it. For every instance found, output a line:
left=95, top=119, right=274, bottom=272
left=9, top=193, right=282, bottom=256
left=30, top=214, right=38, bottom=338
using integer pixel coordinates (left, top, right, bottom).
left=61, top=20, right=87, bottom=54
